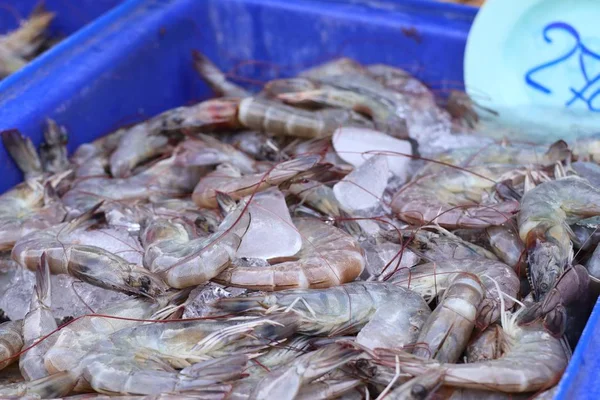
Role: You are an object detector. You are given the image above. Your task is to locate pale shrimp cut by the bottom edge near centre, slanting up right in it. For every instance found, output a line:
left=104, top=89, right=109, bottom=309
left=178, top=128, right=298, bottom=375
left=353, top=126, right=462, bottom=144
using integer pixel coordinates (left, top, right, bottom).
left=249, top=343, right=360, bottom=400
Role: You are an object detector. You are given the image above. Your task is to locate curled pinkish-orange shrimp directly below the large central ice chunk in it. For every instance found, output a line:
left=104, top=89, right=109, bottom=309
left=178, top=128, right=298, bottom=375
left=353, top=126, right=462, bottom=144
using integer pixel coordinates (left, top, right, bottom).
left=213, top=218, right=365, bottom=291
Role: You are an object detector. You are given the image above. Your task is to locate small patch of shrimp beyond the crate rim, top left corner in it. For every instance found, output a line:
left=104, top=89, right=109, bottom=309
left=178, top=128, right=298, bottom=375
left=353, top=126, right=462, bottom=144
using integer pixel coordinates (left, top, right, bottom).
left=0, top=2, right=54, bottom=79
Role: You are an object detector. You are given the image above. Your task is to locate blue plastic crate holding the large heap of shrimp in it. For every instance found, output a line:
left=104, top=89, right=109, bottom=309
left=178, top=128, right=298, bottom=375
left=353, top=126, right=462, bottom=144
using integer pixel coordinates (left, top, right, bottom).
left=0, top=0, right=600, bottom=399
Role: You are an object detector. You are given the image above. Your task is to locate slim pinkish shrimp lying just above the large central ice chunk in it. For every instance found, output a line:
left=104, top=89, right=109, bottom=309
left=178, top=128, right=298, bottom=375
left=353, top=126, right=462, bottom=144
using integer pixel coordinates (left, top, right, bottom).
left=192, top=156, right=322, bottom=208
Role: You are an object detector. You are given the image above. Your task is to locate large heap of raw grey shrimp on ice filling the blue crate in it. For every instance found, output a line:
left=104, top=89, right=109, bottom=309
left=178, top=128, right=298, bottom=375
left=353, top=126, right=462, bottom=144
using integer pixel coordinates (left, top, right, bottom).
left=0, top=53, right=600, bottom=400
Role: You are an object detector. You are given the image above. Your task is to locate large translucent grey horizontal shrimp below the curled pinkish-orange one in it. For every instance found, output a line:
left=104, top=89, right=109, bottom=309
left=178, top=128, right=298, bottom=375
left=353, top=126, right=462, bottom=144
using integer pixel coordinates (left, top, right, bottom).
left=215, top=282, right=431, bottom=348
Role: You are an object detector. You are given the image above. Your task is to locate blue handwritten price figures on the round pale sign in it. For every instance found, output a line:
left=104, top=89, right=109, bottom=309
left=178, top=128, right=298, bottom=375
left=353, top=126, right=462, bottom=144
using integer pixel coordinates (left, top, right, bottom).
left=525, top=22, right=600, bottom=112
